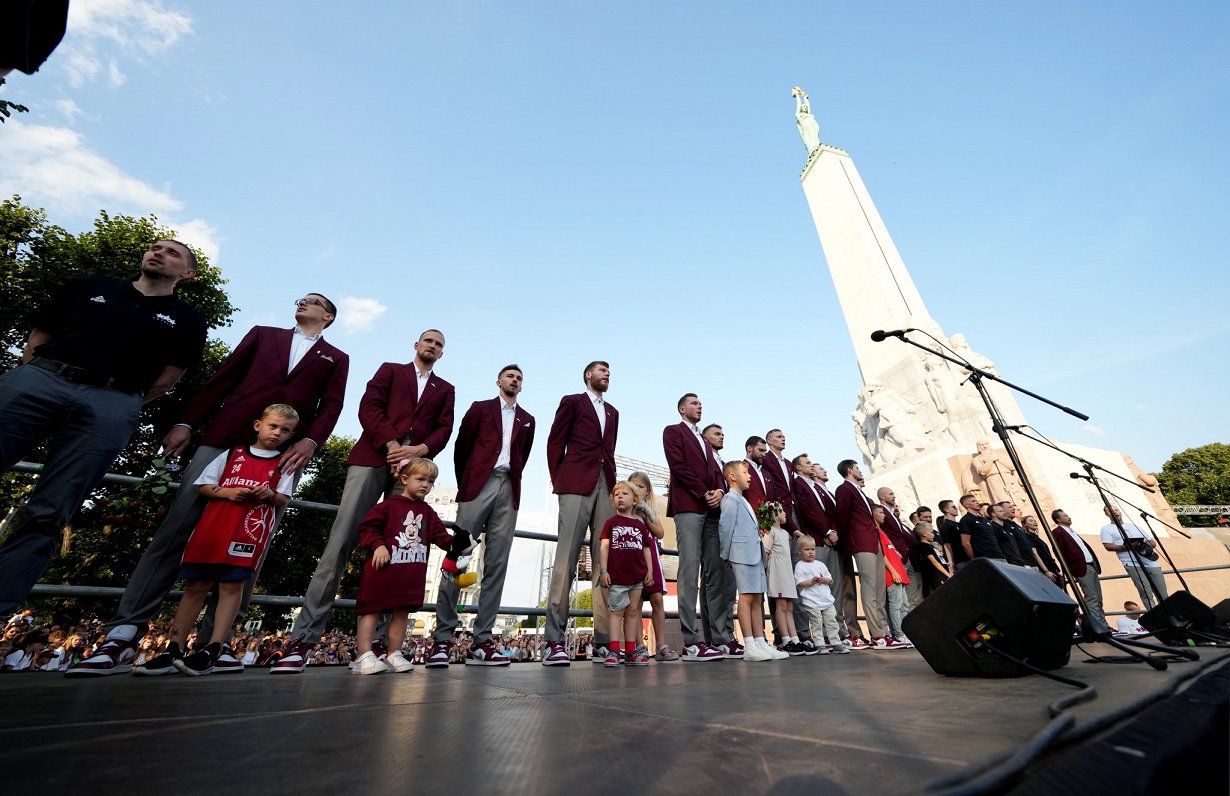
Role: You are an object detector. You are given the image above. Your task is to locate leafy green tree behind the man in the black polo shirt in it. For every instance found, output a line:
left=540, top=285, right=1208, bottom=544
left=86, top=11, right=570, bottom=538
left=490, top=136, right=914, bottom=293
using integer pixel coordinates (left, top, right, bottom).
left=0, top=197, right=235, bottom=611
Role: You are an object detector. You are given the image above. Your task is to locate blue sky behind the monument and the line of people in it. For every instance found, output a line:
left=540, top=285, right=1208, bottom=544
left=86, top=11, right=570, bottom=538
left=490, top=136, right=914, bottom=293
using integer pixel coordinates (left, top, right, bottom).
left=0, top=0, right=1230, bottom=597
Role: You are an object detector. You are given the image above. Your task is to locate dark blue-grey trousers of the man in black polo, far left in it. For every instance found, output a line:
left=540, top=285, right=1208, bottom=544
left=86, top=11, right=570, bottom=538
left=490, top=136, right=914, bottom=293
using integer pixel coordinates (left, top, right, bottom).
left=0, top=364, right=141, bottom=611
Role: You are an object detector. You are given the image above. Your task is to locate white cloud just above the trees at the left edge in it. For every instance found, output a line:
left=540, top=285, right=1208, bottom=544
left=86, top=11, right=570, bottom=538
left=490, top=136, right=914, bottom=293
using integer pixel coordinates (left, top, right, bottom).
left=0, top=121, right=183, bottom=218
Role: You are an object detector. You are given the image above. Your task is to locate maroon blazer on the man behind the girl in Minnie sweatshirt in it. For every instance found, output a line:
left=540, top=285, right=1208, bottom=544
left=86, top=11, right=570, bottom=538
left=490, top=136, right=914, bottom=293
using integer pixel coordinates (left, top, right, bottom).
left=346, top=362, right=455, bottom=468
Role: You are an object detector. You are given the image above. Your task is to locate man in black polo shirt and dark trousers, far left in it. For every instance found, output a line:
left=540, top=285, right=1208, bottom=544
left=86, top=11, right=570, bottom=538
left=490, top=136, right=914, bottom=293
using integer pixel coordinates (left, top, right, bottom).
left=0, top=240, right=205, bottom=611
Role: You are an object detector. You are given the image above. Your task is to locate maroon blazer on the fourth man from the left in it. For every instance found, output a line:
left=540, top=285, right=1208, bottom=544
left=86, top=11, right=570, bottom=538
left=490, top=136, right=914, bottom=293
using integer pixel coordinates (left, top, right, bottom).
left=453, top=396, right=534, bottom=508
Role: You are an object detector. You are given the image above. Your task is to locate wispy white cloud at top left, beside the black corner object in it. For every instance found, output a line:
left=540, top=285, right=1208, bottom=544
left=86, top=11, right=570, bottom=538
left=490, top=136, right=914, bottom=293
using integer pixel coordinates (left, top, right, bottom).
left=53, top=0, right=192, bottom=87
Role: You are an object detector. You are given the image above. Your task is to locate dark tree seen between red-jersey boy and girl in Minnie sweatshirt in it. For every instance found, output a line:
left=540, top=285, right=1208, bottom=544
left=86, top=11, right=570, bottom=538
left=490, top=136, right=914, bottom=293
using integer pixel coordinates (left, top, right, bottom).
left=256, top=437, right=363, bottom=627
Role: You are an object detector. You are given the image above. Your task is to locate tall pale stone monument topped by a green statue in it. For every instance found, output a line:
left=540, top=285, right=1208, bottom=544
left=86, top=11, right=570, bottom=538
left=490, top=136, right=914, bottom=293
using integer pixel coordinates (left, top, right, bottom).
left=792, top=86, right=1200, bottom=553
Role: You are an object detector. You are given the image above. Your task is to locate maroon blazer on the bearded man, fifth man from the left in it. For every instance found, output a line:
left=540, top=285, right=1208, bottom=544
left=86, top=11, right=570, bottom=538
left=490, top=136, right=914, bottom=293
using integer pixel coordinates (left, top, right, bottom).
left=546, top=392, right=619, bottom=495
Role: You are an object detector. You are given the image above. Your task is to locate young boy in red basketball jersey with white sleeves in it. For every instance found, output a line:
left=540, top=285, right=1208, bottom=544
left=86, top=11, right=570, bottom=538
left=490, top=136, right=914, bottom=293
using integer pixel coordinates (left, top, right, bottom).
left=133, top=404, right=299, bottom=675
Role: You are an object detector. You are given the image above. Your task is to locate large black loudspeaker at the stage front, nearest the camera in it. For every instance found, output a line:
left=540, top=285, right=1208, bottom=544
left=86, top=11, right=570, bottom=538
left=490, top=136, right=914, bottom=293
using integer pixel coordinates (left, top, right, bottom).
left=902, top=559, right=1076, bottom=677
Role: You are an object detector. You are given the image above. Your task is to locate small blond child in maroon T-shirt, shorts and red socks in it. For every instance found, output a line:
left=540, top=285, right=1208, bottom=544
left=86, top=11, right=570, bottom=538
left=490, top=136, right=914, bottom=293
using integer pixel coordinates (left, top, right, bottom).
left=598, top=481, right=653, bottom=666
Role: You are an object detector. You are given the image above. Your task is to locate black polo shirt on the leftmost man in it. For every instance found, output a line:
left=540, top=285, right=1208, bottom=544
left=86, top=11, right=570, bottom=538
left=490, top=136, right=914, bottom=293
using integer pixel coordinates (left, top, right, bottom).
left=32, top=277, right=205, bottom=394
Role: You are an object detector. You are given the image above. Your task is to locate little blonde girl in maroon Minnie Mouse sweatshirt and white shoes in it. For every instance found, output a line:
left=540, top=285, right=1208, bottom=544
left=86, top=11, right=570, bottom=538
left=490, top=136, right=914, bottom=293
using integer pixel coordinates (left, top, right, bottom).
left=351, top=459, right=453, bottom=674
